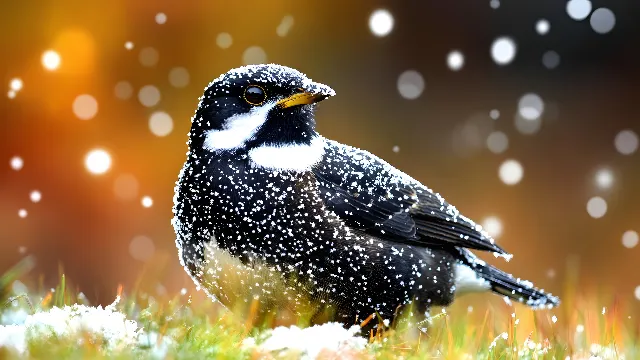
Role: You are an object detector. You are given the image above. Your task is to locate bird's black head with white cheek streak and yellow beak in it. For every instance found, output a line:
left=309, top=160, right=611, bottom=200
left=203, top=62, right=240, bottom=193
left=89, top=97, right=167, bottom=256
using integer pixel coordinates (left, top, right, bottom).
left=190, top=64, right=335, bottom=153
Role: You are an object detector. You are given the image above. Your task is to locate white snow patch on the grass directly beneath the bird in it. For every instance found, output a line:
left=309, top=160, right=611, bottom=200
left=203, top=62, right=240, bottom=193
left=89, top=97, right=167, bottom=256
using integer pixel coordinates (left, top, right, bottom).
left=243, top=323, right=367, bottom=360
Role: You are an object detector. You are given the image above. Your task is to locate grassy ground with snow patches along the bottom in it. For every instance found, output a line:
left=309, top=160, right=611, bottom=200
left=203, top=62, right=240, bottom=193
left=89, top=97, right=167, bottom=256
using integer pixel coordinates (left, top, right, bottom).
left=0, top=263, right=640, bottom=359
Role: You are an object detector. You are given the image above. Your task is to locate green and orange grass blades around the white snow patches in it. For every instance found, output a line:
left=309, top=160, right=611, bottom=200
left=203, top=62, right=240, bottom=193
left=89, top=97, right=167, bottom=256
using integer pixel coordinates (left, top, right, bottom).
left=0, top=261, right=640, bottom=360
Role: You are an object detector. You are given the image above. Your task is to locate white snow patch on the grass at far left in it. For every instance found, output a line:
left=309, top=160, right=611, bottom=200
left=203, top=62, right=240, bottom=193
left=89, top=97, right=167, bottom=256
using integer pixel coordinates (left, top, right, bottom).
left=0, top=298, right=140, bottom=354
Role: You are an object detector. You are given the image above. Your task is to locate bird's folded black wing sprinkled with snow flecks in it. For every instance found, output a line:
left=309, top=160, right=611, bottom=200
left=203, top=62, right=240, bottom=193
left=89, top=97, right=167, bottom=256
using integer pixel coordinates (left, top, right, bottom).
left=312, top=140, right=507, bottom=254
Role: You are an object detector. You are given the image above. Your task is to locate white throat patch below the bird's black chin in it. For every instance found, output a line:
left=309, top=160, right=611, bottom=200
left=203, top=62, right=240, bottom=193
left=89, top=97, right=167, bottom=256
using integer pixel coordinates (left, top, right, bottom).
left=249, top=136, right=324, bottom=172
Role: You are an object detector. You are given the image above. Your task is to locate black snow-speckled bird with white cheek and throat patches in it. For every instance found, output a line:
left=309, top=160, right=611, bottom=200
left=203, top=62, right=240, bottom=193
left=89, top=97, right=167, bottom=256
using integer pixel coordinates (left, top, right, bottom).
left=171, top=64, right=560, bottom=326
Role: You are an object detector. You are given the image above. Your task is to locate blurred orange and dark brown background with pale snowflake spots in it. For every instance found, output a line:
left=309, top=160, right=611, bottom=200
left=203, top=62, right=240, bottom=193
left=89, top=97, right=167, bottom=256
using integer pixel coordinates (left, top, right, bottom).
left=0, top=0, right=640, bottom=310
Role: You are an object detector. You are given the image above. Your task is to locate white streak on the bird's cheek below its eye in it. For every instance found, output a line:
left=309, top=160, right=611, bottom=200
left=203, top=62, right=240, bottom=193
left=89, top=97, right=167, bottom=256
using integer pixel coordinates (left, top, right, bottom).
left=203, top=102, right=276, bottom=151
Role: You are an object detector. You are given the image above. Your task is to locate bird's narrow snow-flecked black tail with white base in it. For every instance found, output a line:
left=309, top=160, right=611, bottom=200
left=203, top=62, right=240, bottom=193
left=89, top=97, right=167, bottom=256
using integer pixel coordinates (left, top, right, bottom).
left=456, top=250, right=560, bottom=309
